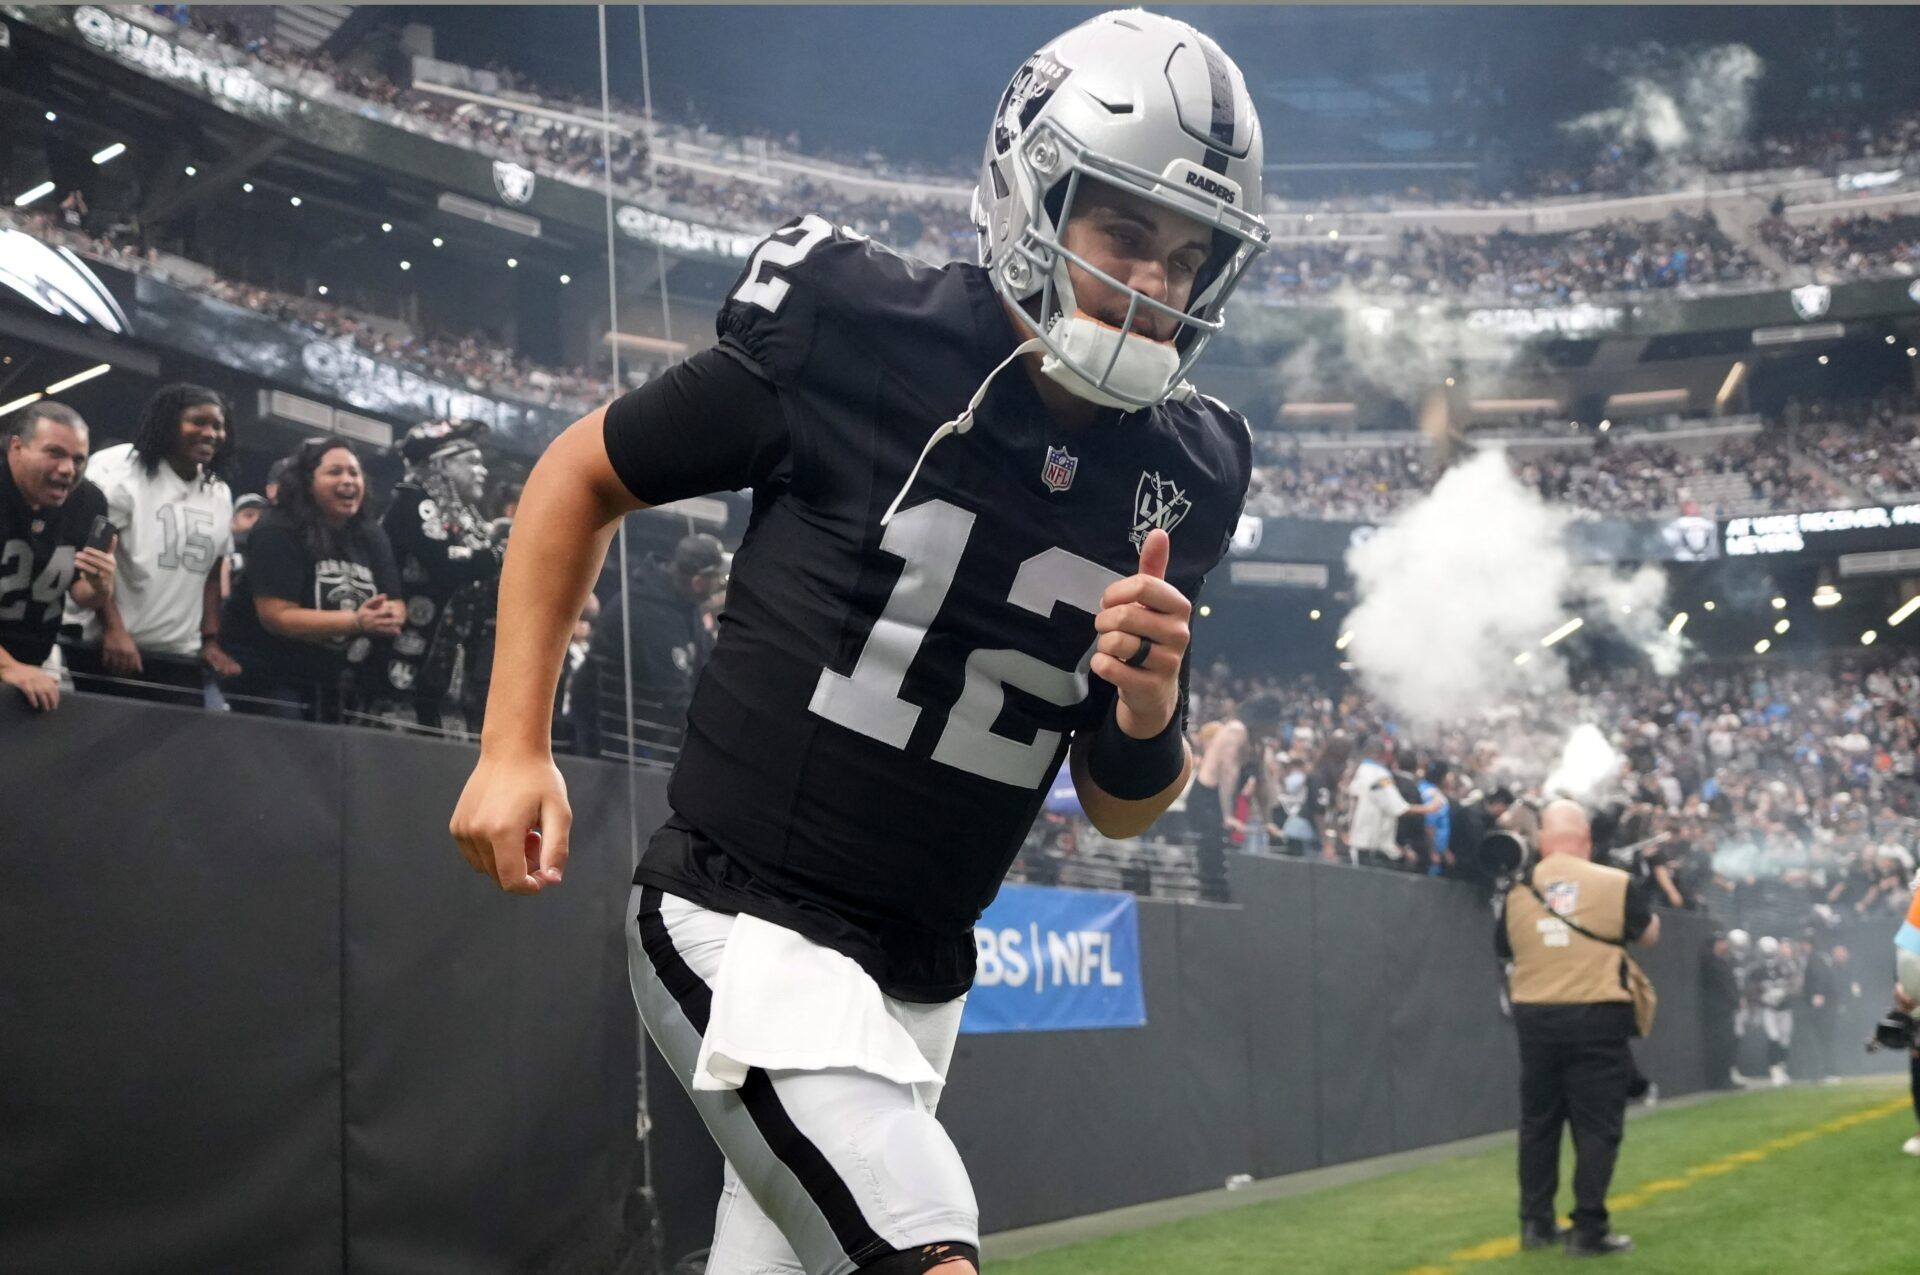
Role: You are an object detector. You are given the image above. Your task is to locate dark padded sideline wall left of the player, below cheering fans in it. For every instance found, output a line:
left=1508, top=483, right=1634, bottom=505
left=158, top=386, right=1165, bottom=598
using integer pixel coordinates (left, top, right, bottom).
left=0, top=695, right=659, bottom=1275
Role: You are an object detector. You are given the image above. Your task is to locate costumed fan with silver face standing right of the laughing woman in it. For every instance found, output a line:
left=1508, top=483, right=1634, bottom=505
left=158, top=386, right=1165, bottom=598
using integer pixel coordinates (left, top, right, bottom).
left=372, top=421, right=505, bottom=728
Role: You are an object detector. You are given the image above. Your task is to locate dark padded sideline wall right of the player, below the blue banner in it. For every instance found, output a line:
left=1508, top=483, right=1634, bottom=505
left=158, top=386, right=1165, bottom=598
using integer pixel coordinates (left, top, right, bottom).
left=941, top=860, right=1903, bottom=1231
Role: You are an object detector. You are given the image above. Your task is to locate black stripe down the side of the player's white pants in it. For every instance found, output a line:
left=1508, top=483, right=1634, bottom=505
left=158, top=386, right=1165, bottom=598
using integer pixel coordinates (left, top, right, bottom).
left=637, top=885, right=899, bottom=1265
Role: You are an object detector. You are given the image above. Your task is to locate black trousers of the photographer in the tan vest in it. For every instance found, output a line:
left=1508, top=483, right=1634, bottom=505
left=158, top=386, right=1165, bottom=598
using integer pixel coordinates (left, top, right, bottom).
left=1521, top=1035, right=1634, bottom=1235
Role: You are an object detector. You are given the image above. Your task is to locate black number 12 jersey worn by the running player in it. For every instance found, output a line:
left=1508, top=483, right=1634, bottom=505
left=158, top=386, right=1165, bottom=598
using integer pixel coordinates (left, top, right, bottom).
left=607, top=217, right=1250, bottom=1000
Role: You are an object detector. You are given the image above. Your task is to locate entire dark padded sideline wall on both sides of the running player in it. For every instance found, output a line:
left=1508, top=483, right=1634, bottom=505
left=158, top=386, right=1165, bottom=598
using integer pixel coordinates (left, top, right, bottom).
left=0, top=697, right=1899, bottom=1275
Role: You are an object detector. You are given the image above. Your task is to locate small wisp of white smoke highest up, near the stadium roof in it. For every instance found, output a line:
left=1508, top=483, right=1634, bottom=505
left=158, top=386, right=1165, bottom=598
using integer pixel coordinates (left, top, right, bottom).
left=1561, top=44, right=1766, bottom=182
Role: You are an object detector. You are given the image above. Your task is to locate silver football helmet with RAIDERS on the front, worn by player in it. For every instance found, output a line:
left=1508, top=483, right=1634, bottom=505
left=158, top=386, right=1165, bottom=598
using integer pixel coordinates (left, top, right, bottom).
left=973, top=10, right=1267, bottom=409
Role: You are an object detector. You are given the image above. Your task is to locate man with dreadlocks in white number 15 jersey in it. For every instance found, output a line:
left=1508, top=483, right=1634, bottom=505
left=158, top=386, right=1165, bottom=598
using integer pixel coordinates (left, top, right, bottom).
left=65, top=384, right=240, bottom=705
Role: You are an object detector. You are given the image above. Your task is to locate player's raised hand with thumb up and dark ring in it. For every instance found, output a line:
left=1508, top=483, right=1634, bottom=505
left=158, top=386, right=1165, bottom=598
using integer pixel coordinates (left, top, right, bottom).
left=1092, top=528, right=1192, bottom=739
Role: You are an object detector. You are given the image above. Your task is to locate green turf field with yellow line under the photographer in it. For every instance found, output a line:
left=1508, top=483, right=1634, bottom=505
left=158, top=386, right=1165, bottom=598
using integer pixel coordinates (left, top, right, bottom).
left=987, top=1077, right=1920, bottom=1275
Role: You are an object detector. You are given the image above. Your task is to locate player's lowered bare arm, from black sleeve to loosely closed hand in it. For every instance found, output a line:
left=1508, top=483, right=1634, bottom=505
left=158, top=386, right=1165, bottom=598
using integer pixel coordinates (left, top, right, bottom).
left=447, top=409, right=645, bottom=895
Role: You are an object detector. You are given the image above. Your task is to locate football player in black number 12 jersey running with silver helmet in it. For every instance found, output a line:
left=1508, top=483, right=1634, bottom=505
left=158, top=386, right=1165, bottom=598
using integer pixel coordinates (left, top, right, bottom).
left=451, top=10, right=1267, bottom=1275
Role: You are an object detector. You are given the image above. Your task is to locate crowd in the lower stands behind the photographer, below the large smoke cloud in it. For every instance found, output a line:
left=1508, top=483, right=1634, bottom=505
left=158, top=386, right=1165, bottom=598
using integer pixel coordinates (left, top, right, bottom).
left=1190, top=653, right=1920, bottom=935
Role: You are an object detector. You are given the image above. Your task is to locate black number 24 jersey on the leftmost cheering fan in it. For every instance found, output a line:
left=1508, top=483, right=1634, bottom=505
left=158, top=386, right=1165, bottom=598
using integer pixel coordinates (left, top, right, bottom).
left=0, top=455, right=108, bottom=664
